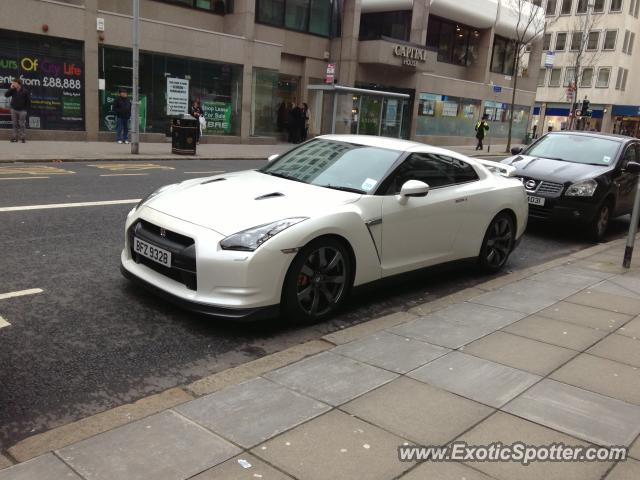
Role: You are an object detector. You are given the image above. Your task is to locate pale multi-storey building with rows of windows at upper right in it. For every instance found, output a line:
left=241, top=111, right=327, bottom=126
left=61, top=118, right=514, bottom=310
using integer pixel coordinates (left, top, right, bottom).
left=533, top=0, right=640, bottom=136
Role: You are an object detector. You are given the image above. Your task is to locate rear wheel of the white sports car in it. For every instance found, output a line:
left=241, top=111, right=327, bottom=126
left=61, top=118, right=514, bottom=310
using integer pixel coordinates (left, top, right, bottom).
left=478, top=212, right=516, bottom=273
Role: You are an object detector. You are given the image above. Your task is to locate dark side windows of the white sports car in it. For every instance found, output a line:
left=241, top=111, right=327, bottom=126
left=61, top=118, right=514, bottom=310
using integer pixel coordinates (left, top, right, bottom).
left=386, top=153, right=478, bottom=195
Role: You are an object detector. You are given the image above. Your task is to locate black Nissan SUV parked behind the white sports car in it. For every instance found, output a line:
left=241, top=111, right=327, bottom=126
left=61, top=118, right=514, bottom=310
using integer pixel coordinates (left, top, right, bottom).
left=503, top=131, right=640, bottom=241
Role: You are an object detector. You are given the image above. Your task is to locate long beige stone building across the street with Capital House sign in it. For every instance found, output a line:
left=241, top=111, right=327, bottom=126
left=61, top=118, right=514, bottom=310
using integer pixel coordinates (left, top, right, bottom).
left=0, top=0, right=542, bottom=145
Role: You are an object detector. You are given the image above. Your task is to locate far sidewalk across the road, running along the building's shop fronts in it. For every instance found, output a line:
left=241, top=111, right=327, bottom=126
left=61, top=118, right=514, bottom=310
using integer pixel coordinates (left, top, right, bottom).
left=0, top=141, right=506, bottom=163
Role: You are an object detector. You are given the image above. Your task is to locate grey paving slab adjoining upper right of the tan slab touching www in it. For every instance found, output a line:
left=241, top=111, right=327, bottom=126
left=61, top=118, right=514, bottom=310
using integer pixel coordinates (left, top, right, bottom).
left=408, top=352, right=541, bottom=408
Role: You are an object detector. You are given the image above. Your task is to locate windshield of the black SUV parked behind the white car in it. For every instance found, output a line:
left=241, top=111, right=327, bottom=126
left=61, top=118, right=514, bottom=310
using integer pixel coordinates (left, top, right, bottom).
left=524, top=134, right=620, bottom=166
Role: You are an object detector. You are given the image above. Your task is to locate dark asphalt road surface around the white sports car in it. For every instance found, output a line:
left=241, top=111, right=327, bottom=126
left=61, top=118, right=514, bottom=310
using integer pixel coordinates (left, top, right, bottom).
left=0, top=160, right=628, bottom=451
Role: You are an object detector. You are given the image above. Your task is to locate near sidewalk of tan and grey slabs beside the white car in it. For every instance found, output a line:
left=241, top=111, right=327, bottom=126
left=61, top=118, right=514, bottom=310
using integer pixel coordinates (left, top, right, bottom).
left=0, top=240, right=640, bottom=480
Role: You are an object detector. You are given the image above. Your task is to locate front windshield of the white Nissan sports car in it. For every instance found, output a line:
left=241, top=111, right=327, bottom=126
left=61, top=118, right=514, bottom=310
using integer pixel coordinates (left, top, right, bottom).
left=259, top=139, right=402, bottom=193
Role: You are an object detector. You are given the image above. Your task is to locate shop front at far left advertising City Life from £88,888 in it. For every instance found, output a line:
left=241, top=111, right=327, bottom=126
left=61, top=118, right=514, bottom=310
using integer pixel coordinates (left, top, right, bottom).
left=0, top=30, right=85, bottom=131
